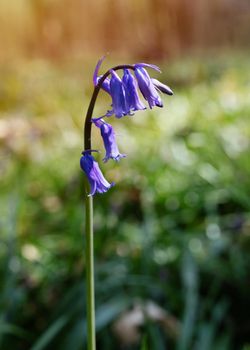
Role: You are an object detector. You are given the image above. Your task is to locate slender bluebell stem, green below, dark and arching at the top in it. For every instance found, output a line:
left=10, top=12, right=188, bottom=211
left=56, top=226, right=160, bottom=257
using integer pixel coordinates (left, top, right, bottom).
left=84, top=61, right=134, bottom=350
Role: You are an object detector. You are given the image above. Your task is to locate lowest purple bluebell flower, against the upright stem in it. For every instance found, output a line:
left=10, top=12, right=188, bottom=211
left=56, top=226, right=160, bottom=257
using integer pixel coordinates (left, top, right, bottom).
left=80, top=151, right=114, bottom=196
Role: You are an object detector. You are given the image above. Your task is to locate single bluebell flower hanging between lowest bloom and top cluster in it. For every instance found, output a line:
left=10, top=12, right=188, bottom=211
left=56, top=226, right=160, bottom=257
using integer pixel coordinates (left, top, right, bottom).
left=92, top=118, right=126, bottom=162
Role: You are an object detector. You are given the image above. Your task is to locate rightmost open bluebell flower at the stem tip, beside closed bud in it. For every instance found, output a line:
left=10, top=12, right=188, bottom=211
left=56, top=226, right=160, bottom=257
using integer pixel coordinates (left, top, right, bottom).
left=134, top=63, right=163, bottom=108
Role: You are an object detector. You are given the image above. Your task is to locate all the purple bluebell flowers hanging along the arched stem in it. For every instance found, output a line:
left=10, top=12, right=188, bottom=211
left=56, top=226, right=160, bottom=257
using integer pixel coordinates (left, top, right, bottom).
left=80, top=57, right=173, bottom=196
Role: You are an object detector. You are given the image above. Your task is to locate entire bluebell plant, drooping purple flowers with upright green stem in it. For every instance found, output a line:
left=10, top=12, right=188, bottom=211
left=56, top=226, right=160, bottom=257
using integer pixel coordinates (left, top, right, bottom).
left=80, top=58, right=173, bottom=350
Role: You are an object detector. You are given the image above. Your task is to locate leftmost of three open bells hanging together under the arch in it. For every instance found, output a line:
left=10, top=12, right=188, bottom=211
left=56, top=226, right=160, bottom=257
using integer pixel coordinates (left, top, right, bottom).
left=110, top=70, right=130, bottom=118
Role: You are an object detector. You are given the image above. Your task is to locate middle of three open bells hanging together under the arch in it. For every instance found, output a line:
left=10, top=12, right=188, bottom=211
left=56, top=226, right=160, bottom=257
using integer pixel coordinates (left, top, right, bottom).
left=122, top=69, right=146, bottom=111
